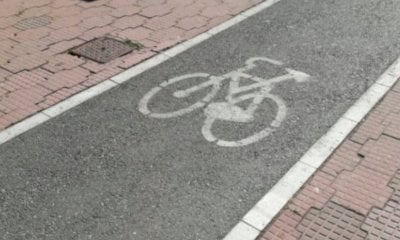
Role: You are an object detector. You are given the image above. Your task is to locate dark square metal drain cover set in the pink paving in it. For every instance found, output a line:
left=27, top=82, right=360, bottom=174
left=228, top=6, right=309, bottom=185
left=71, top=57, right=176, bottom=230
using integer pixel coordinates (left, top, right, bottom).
left=69, top=37, right=139, bottom=63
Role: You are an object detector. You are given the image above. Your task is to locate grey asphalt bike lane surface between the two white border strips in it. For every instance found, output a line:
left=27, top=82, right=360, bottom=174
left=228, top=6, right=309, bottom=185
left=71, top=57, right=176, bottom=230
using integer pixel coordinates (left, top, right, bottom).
left=0, top=0, right=400, bottom=240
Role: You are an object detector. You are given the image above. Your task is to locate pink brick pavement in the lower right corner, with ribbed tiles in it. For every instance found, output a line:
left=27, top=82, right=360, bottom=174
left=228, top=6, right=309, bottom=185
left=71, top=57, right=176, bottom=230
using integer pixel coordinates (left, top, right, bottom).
left=259, top=81, right=400, bottom=240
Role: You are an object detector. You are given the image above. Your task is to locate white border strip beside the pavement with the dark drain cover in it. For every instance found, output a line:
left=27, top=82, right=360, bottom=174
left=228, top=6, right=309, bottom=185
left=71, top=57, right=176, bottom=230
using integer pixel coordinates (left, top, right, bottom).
left=0, top=0, right=280, bottom=145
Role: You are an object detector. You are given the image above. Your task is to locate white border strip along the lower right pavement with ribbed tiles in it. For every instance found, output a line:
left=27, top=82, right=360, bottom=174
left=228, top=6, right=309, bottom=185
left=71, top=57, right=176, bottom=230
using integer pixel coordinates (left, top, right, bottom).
left=224, top=57, right=400, bottom=240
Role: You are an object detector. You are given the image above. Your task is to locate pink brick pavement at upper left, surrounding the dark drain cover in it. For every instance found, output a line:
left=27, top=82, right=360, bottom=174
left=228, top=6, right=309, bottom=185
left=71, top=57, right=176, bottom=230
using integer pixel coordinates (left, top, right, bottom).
left=0, top=0, right=262, bottom=131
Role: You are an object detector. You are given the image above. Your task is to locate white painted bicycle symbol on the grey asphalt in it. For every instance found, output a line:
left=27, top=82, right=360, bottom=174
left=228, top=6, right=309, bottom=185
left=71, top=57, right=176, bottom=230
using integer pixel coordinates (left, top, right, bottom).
left=139, top=57, right=310, bottom=147
